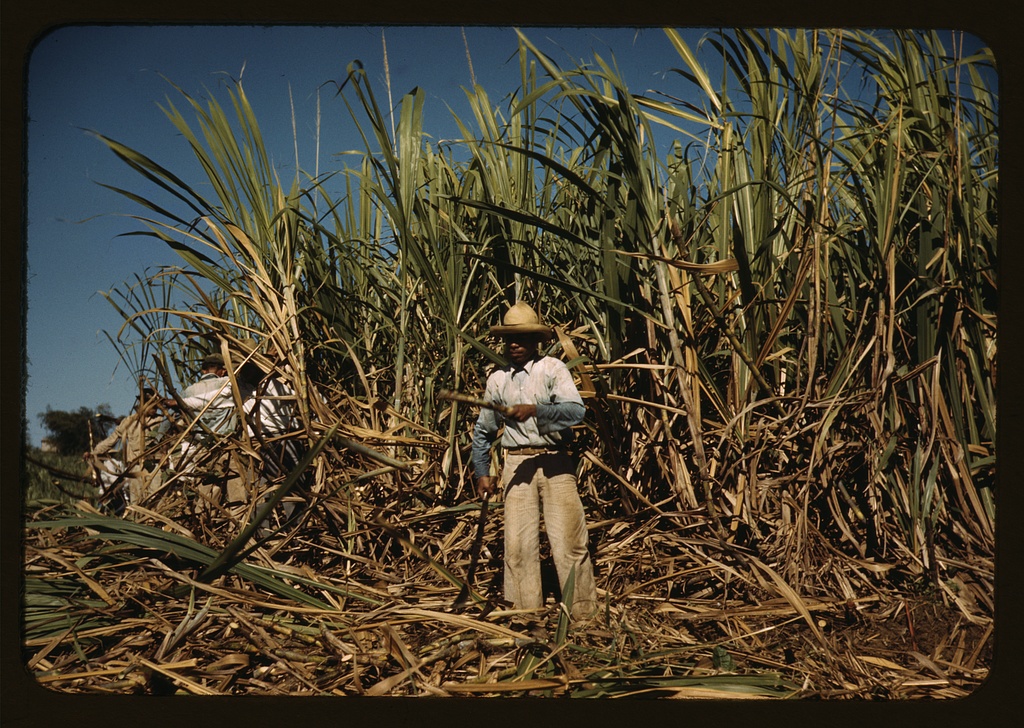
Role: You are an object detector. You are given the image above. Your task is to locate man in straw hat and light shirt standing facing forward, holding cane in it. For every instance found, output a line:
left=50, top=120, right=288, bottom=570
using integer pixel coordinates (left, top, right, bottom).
left=473, top=302, right=597, bottom=617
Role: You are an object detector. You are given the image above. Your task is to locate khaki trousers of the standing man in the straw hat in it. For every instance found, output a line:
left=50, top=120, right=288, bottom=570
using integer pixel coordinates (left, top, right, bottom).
left=502, top=452, right=597, bottom=617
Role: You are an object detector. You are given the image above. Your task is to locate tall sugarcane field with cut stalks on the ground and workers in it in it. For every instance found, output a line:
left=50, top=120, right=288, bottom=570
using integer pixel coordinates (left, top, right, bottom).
left=22, top=29, right=999, bottom=703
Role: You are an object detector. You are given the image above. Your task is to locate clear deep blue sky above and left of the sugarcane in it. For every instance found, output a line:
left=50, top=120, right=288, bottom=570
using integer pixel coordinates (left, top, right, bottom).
left=26, top=26, right=699, bottom=444
